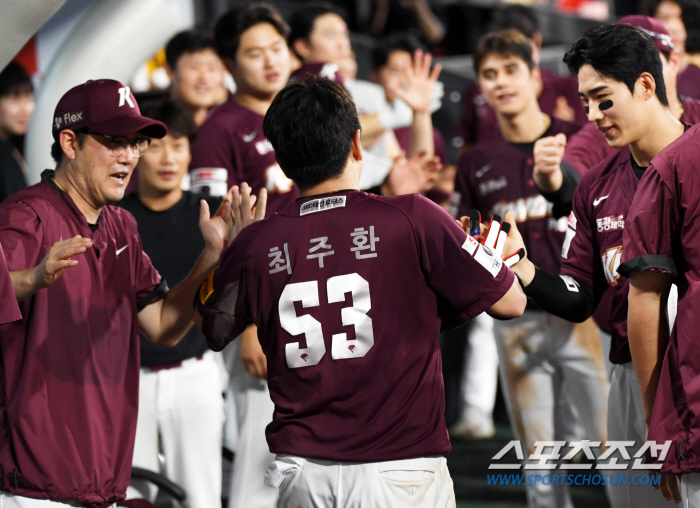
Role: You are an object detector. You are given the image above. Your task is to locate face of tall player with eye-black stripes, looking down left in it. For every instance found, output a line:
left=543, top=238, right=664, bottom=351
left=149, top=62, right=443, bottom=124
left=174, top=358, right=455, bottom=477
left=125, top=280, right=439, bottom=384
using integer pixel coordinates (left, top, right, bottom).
left=578, top=64, right=653, bottom=148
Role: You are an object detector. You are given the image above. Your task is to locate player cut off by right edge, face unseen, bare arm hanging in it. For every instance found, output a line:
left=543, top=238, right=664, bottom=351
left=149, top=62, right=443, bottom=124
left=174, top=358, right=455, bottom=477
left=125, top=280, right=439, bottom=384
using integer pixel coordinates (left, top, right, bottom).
left=618, top=30, right=700, bottom=508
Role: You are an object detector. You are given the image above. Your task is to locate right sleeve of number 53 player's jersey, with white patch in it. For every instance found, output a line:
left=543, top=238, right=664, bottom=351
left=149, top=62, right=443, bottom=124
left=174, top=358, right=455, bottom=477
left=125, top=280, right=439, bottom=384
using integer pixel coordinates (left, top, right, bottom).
left=404, top=197, right=515, bottom=325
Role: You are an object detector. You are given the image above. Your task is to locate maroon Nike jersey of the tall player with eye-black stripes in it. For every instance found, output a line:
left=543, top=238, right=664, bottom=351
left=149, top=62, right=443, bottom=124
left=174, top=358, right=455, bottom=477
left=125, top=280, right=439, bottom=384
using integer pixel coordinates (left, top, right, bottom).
left=560, top=147, right=639, bottom=364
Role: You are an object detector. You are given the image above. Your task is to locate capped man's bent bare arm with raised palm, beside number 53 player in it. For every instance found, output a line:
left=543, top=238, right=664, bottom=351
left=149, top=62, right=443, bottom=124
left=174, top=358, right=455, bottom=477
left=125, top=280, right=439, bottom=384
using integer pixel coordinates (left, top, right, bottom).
left=139, top=183, right=267, bottom=346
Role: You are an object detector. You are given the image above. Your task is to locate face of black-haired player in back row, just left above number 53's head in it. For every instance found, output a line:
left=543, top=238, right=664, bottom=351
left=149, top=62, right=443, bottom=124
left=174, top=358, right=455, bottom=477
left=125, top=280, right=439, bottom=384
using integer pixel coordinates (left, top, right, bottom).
left=230, top=23, right=290, bottom=99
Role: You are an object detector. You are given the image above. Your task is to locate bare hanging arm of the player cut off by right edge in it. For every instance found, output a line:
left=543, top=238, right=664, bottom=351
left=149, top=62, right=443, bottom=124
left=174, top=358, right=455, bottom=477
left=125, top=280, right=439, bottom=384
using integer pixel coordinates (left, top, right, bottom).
left=627, top=271, right=673, bottom=427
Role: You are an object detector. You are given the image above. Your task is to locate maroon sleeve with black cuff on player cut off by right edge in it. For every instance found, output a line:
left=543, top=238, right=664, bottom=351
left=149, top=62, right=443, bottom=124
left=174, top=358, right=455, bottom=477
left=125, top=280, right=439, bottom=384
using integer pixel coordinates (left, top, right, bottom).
left=617, top=163, right=680, bottom=277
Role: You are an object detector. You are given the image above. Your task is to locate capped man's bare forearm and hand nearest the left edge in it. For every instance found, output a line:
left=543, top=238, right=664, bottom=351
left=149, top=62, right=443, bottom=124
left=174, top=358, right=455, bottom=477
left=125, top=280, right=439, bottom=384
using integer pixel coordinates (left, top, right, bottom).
left=10, top=236, right=92, bottom=302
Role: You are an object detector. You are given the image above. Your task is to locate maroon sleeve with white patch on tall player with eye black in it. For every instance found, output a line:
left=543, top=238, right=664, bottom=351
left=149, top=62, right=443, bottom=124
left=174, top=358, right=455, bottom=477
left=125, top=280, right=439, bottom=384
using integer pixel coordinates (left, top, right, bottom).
left=559, top=181, right=604, bottom=287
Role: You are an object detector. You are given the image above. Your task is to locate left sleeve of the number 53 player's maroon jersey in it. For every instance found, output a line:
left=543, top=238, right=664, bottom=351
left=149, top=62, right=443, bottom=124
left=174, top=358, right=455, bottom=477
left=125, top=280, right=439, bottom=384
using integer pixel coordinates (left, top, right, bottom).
left=195, top=224, right=257, bottom=351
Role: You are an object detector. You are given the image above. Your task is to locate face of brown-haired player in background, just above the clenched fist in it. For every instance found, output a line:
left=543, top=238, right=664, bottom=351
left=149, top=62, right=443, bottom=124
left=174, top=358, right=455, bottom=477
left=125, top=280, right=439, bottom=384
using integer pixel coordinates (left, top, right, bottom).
left=479, top=53, right=539, bottom=116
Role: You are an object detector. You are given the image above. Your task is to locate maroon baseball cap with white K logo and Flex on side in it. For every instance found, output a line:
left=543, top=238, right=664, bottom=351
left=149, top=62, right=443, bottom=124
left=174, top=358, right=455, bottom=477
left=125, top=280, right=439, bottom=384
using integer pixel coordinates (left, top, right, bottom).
left=53, top=79, right=168, bottom=140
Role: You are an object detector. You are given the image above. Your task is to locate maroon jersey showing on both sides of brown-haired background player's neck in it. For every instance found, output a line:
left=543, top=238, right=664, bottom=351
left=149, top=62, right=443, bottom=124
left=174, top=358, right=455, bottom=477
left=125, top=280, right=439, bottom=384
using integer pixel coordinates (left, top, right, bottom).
left=455, top=69, right=588, bottom=145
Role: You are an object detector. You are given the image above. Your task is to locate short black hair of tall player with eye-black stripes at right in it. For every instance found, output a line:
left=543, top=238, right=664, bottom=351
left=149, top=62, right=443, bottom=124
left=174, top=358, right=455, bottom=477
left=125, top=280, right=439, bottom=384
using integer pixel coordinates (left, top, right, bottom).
left=564, top=24, right=668, bottom=106
